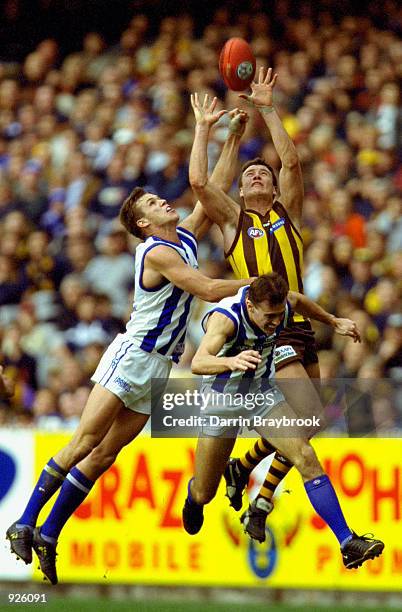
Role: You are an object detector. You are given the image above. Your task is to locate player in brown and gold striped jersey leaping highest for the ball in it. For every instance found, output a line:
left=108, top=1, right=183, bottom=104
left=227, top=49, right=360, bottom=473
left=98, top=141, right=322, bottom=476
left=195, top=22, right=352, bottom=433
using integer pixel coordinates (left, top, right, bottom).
left=190, top=68, right=336, bottom=541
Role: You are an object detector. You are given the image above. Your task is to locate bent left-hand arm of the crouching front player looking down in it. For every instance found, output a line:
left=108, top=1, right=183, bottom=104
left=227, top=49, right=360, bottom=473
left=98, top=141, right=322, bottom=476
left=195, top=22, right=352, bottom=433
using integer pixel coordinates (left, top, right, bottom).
left=191, top=312, right=261, bottom=374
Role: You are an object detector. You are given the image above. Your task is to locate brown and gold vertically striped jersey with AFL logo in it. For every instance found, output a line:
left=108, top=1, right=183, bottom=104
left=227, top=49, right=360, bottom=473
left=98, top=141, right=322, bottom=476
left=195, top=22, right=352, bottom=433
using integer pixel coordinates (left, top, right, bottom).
left=225, top=202, right=305, bottom=321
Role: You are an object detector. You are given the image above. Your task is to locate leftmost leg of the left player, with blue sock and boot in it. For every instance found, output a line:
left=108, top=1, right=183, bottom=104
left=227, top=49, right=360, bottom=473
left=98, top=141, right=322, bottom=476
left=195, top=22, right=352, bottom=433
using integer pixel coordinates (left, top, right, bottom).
left=6, top=384, right=123, bottom=564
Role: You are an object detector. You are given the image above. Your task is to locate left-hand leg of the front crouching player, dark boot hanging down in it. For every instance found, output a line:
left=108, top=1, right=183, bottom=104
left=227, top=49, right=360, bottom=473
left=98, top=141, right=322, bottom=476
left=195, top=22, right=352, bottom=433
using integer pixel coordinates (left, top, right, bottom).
left=183, top=437, right=235, bottom=535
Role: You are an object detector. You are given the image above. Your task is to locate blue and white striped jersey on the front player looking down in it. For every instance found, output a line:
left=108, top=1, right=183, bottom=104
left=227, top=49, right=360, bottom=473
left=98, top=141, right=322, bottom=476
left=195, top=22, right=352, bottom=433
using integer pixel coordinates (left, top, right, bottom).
left=202, top=286, right=292, bottom=394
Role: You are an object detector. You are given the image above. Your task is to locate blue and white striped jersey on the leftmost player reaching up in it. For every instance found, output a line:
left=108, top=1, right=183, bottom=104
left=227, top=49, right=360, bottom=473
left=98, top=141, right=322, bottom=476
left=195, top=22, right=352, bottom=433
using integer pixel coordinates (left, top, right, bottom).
left=126, top=227, right=198, bottom=361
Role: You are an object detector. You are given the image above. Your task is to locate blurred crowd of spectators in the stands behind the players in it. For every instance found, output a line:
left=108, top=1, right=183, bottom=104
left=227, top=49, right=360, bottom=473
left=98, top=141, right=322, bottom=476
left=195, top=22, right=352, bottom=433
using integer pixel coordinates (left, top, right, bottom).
left=0, top=0, right=402, bottom=429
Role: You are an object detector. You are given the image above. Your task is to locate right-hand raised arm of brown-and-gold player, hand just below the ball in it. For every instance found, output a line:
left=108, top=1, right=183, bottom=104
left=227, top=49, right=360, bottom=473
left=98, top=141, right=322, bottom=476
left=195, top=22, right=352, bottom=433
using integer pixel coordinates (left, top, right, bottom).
left=240, top=67, right=304, bottom=225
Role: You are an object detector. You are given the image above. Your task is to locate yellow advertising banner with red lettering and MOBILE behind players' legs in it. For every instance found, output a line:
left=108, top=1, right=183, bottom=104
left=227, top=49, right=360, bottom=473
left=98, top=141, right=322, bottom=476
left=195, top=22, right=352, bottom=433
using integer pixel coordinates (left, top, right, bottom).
left=35, top=434, right=402, bottom=590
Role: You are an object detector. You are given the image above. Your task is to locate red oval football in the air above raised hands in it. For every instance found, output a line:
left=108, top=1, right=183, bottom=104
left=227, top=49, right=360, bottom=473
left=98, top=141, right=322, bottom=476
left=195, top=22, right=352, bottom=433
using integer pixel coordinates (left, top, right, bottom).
left=219, top=38, right=255, bottom=91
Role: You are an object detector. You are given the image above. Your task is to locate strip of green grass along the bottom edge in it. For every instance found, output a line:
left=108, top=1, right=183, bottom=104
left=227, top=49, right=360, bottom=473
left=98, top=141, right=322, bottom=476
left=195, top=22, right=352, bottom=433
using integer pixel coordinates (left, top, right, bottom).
left=0, top=594, right=385, bottom=612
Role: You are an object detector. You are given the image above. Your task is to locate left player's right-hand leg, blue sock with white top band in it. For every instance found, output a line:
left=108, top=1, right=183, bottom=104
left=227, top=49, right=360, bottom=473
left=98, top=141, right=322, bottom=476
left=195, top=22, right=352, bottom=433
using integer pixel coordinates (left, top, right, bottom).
left=33, top=407, right=149, bottom=584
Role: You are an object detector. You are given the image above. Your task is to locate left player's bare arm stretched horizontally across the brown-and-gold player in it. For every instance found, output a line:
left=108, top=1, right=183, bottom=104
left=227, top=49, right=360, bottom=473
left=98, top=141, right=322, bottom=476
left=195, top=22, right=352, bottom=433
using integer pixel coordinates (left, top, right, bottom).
left=144, top=245, right=253, bottom=302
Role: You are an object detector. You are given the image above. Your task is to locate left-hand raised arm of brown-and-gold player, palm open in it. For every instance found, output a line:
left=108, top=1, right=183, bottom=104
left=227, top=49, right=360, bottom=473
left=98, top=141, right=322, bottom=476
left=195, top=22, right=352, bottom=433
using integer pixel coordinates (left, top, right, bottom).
left=189, top=94, right=240, bottom=229
